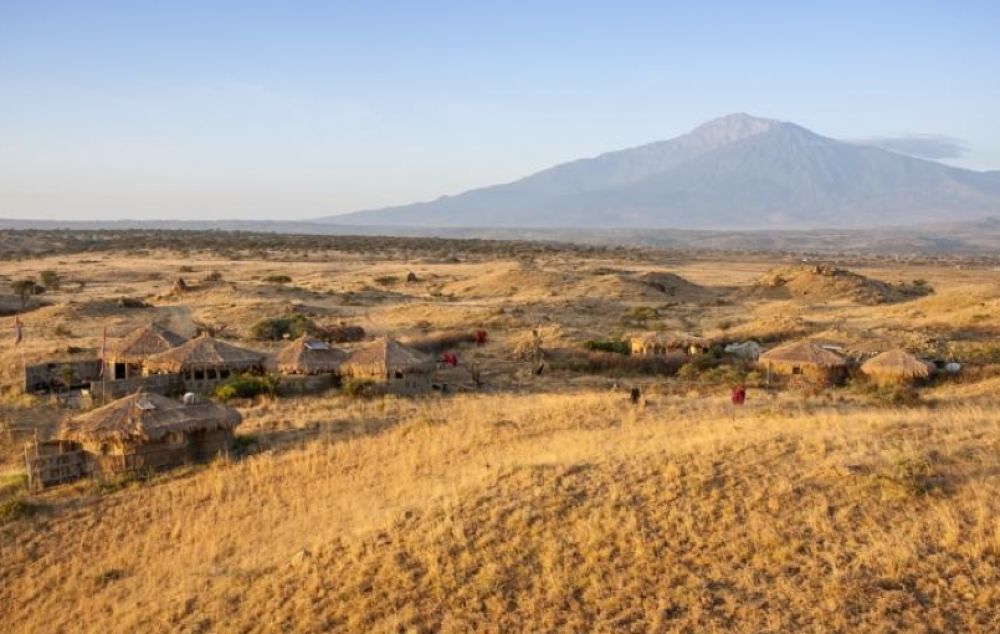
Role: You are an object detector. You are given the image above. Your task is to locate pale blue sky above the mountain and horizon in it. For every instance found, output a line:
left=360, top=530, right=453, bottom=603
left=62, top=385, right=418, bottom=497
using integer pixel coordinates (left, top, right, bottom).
left=0, top=0, right=1000, bottom=220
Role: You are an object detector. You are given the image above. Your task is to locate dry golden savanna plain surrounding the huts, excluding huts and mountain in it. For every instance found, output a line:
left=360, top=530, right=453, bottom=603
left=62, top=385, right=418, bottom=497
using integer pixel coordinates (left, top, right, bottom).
left=0, top=230, right=1000, bottom=632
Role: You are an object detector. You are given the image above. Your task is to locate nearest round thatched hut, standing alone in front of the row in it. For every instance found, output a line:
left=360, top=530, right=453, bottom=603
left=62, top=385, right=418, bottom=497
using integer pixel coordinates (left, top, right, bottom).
left=59, top=392, right=241, bottom=474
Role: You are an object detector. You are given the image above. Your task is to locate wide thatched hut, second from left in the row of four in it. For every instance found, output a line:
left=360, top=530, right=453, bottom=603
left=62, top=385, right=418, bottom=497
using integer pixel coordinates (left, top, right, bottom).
left=146, top=335, right=265, bottom=392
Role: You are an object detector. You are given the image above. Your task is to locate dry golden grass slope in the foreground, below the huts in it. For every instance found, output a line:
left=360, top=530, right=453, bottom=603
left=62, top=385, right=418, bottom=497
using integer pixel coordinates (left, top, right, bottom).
left=0, top=392, right=1000, bottom=632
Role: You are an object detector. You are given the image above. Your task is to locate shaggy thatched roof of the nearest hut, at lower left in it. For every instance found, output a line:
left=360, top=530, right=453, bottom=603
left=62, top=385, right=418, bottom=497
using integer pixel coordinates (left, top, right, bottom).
left=59, top=392, right=241, bottom=441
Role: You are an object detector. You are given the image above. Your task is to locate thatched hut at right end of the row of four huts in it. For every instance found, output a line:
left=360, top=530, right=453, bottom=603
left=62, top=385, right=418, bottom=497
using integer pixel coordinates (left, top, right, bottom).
left=340, top=337, right=437, bottom=392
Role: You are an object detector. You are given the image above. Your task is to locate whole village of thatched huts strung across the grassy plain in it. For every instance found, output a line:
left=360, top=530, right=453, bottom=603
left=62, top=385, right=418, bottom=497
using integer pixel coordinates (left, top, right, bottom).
left=7, top=256, right=961, bottom=490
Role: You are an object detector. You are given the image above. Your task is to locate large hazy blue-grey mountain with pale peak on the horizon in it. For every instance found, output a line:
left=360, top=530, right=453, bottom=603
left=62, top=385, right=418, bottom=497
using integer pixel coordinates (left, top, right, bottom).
left=321, top=114, right=1000, bottom=229
